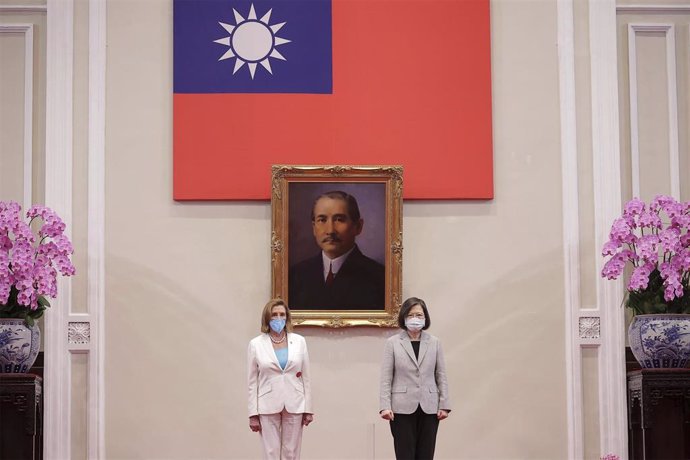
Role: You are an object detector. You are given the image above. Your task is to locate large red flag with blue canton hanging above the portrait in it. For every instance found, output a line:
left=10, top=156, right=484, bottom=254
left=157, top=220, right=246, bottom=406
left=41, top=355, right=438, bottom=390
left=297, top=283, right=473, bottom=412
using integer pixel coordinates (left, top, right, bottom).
left=173, top=0, right=493, bottom=200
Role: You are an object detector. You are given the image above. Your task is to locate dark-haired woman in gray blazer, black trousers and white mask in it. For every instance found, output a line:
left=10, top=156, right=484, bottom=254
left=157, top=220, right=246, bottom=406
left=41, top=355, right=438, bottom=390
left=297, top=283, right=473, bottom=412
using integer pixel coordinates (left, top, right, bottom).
left=379, top=297, right=451, bottom=460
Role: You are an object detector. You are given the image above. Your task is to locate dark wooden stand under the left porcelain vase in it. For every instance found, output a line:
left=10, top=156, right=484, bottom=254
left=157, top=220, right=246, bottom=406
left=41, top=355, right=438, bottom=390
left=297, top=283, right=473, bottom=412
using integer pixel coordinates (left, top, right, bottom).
left=0, top=374, right=43, bottom=460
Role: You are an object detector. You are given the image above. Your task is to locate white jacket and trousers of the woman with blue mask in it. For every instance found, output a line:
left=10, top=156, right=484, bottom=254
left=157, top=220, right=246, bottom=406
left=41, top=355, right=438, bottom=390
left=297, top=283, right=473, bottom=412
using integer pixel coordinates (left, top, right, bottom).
left=247, top=333, right=313, bottom=460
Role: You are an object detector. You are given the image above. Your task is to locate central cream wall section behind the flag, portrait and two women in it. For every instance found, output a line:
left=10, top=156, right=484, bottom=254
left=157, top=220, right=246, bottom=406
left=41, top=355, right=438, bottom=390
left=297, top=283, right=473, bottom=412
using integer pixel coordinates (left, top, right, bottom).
left=105, top=0, right=567, bottom=459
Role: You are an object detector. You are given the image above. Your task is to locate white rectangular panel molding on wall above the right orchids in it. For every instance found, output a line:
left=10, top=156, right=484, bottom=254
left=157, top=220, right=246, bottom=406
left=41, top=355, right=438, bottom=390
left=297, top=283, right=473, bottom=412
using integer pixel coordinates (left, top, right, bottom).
left=628, top=23, right=690, bottom=199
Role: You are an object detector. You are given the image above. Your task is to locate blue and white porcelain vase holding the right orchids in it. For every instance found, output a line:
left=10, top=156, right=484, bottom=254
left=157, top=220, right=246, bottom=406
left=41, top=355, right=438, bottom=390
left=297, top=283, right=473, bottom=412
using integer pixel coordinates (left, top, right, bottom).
left=628, top=314, right=690, bottom=368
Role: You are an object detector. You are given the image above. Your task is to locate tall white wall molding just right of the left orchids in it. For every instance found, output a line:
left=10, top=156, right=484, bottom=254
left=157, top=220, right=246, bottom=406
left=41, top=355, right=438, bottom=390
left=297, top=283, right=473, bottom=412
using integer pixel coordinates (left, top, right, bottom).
left=42, top=0, right=106, bottom=460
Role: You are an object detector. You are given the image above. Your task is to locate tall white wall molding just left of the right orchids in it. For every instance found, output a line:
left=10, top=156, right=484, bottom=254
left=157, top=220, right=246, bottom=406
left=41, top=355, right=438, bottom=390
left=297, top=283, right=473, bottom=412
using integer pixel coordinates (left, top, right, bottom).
left=557, top=0, right=627, bottom=460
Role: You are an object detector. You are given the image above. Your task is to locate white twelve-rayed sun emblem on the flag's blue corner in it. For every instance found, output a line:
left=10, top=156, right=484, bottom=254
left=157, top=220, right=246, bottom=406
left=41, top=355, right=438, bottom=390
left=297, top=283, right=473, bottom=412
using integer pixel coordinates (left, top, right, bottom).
left=213, top=4, right=290, bottom=80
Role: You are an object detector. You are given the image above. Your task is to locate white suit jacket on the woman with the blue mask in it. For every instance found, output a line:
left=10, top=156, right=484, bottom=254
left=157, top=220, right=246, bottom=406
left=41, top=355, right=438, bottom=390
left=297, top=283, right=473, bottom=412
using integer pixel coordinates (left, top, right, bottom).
left=247, top=332, right=313, bottom=417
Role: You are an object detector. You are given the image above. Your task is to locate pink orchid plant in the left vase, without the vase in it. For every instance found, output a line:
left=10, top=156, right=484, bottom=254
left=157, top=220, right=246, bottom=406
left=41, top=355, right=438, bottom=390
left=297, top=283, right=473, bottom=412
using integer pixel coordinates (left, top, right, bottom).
left=0, top=201, right=75, bottom=326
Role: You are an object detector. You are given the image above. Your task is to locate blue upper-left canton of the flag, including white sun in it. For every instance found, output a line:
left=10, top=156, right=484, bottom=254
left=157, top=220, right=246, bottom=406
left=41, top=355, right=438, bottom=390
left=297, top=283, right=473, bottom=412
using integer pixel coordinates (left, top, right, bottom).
left=173, top=0, right=333, bottom=94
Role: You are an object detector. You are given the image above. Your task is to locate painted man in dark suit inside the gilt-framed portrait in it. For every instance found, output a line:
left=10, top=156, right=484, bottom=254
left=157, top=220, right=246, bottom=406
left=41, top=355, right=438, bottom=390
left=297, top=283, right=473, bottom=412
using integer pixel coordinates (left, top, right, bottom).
left=288, top=189, right=386, bottom=310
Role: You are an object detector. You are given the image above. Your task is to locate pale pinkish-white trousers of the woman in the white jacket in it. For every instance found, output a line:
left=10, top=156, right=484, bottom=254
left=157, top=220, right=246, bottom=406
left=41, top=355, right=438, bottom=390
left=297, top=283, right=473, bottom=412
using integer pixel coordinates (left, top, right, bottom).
left=259, top=409, right=302, bottom=460
